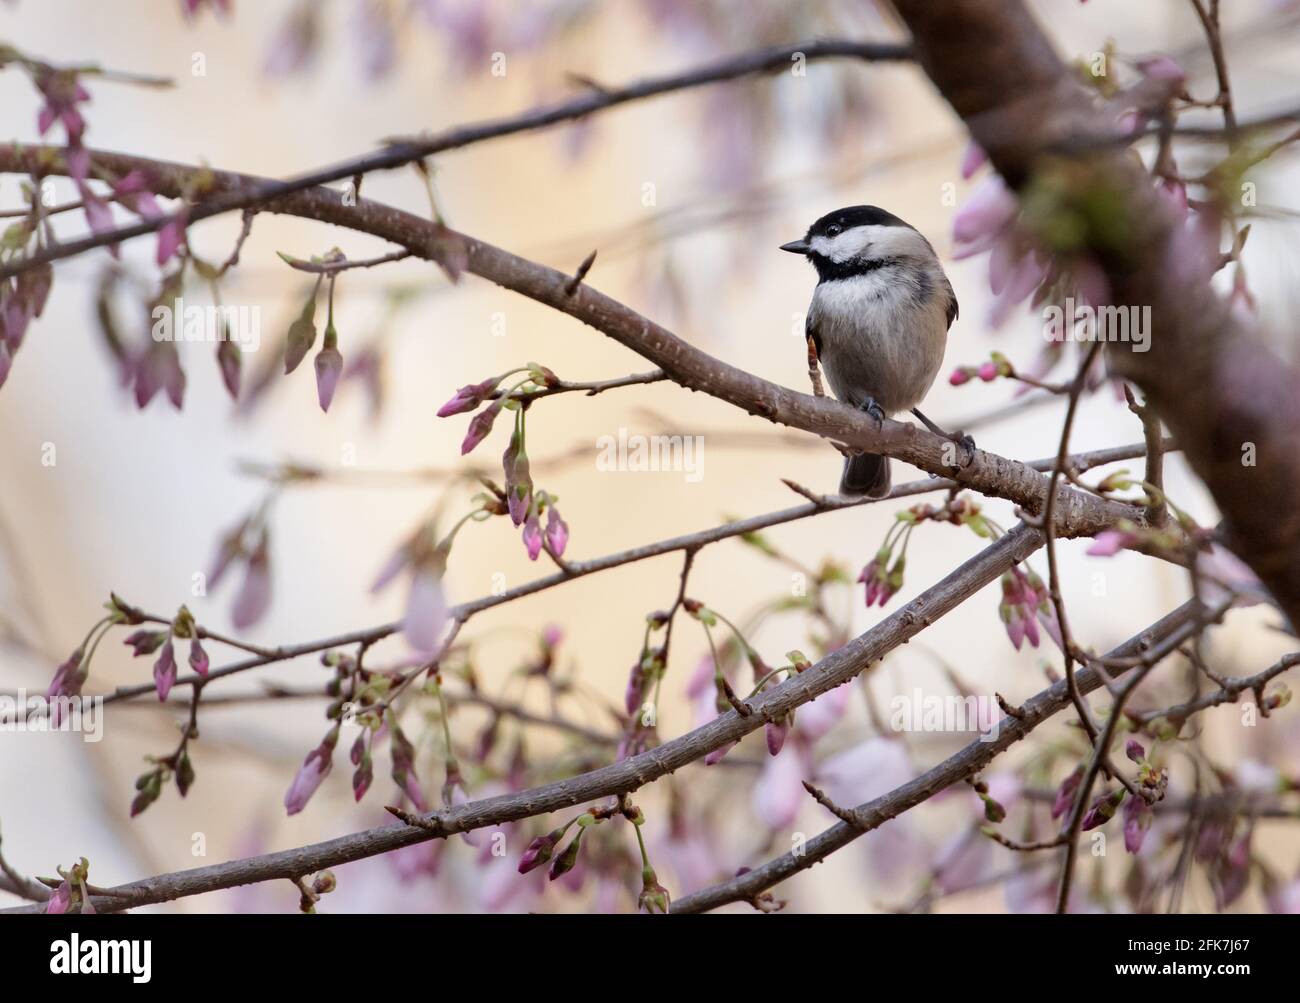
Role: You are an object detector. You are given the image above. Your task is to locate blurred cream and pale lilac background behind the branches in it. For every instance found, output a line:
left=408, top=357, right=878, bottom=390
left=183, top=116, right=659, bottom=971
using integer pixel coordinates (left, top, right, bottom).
left=0, top=0, right=1300, bottom=911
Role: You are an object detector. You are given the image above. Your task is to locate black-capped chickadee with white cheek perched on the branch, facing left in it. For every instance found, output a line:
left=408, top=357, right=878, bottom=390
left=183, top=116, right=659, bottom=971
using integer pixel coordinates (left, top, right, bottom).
left=781, top=205, right=974, bottom=498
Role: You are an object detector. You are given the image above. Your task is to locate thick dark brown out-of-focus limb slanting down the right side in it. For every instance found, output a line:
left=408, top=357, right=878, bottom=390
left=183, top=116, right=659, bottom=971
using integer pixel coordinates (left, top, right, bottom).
left=896, top=0, right=1300, bottom=624
